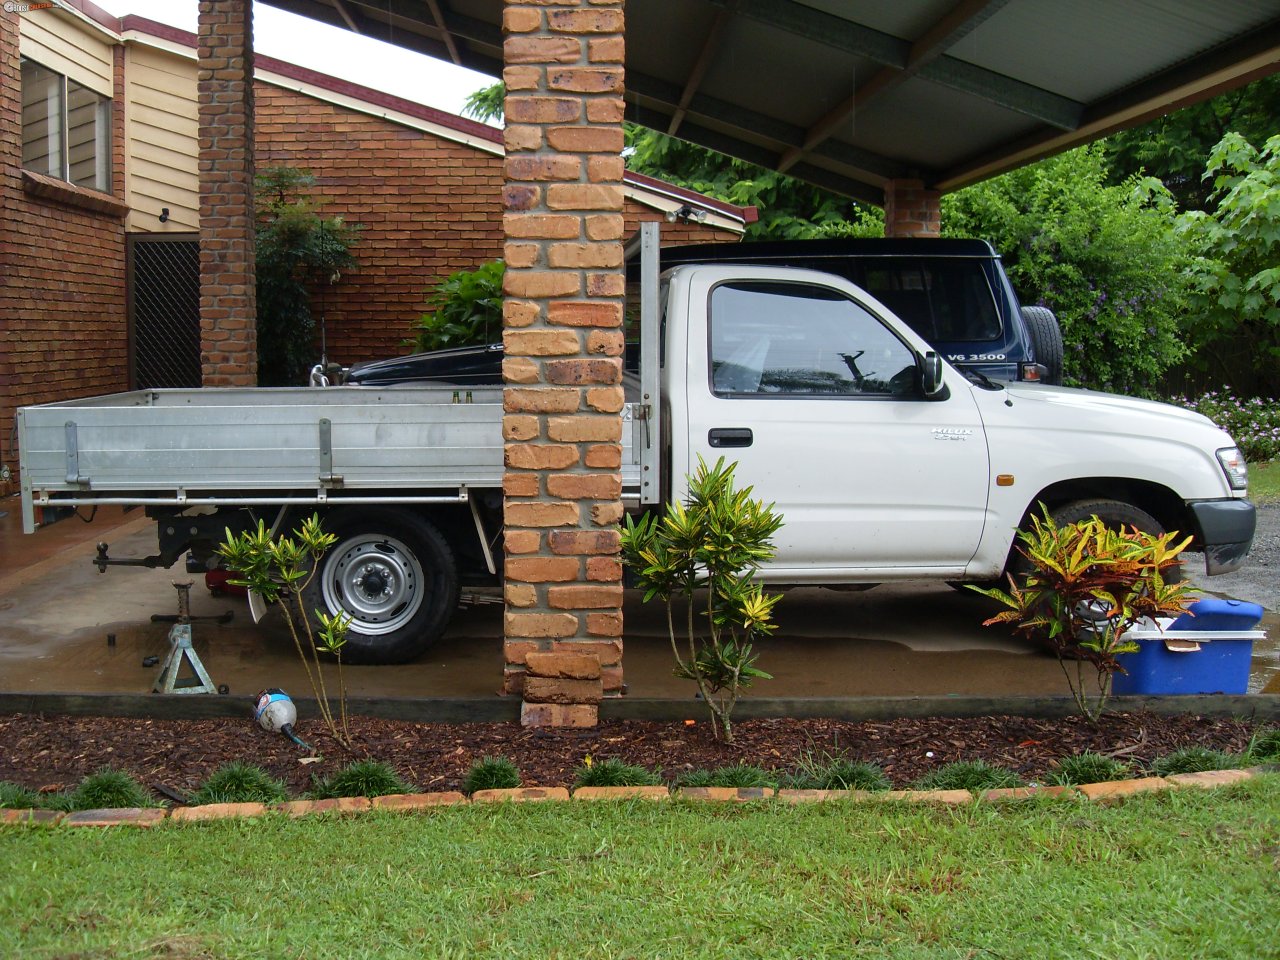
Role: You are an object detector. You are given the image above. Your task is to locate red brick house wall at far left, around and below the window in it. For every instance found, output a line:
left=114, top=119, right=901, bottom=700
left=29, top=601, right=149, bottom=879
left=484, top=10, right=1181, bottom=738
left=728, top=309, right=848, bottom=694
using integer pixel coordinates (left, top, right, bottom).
left=0, top=12, right=128, bottom=493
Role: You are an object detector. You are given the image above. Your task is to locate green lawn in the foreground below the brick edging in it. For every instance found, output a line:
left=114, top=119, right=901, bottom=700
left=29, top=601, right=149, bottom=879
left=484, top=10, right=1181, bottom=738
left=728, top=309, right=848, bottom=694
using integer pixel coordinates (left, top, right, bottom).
left=0, top=774, right=1280, bottom=960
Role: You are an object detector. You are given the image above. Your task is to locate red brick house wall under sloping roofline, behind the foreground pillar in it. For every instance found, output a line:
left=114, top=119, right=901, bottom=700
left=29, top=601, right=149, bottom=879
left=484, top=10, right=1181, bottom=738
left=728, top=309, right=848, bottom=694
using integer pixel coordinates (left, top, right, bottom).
left=255, top=82, right=739, bottom=364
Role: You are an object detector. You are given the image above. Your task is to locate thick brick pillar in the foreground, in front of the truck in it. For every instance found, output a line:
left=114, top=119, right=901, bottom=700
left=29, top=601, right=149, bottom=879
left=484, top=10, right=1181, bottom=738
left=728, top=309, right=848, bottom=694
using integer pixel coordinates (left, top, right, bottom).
left=503, top=0, right=625, bottom=726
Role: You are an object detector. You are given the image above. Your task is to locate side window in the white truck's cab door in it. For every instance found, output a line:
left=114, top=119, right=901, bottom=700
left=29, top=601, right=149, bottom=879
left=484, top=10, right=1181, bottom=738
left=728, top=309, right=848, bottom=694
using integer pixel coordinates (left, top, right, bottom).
left=710, top=282, right=915, bottom=397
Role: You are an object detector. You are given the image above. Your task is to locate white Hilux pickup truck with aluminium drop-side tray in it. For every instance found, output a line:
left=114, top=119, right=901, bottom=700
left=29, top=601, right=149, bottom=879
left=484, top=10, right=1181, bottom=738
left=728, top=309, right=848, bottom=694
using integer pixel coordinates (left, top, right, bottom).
left=18, top=230, right=1254, bottom=663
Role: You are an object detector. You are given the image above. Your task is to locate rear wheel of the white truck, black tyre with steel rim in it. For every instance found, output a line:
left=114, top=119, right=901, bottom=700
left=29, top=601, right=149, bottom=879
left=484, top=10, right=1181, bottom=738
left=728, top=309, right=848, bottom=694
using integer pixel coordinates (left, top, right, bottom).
left=302, top=508, right=458, bottom=663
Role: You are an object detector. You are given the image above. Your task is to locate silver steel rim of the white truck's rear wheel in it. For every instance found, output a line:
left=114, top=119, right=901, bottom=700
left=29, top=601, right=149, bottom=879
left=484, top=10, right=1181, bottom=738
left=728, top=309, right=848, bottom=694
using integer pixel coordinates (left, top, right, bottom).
left=321, top=534, right=425, bottom=636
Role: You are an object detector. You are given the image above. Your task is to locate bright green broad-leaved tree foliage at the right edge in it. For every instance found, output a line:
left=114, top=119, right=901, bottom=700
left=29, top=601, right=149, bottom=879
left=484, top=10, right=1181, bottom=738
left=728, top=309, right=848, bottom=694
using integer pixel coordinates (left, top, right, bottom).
left=1178, top=133, right=1280, bottom=396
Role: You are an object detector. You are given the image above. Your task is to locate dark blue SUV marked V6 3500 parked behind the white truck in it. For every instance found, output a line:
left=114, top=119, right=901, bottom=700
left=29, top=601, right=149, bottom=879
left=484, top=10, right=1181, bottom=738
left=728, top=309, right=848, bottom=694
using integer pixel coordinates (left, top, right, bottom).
left=342, top=238, right=1062, bottom=387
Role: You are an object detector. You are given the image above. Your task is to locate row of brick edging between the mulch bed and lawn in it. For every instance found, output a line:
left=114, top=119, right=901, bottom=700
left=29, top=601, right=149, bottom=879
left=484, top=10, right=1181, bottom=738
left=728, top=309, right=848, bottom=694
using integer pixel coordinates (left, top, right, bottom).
left=0, top=767, right=1276, bottom=827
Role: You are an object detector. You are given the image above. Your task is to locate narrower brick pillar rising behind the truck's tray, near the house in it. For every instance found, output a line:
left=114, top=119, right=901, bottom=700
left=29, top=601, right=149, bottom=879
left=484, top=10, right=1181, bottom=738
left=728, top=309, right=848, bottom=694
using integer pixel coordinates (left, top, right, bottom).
left=197, top=0, right=257, bottom=387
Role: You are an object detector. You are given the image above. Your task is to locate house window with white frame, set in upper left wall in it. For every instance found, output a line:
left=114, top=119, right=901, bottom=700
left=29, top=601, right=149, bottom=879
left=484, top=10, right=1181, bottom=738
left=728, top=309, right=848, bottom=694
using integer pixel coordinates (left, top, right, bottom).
left=22, top=59, right=111, bottom=193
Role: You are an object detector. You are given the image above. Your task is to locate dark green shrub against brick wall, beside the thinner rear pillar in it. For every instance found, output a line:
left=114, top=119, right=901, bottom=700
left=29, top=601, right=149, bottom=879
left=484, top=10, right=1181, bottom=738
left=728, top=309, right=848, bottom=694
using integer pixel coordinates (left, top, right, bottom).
left=256, top=166, right=358, bottom=387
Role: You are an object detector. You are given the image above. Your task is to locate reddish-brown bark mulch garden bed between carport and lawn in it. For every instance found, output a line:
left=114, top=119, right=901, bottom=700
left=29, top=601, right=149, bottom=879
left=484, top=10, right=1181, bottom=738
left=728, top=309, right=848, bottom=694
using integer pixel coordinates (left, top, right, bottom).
left=0, top=713, right=1253, bottom=799
